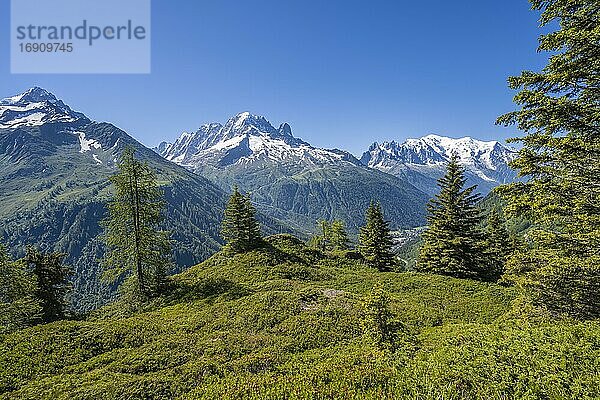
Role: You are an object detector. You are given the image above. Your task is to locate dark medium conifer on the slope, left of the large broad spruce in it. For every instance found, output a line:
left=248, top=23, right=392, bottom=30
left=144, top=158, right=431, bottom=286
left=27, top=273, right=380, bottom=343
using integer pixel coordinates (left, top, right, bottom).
left=358, top=202, right=396, bottom=272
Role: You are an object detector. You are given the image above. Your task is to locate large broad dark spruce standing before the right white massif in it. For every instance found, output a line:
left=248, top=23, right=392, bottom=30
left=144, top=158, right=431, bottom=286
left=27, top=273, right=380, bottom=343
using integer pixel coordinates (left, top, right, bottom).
left=416, top=155, right=486, bottom=279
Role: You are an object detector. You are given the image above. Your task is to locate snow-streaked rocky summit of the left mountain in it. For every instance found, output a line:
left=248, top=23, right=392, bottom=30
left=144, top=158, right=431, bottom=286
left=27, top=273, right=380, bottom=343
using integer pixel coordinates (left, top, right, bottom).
left=0, top=87, right=89, bottom=128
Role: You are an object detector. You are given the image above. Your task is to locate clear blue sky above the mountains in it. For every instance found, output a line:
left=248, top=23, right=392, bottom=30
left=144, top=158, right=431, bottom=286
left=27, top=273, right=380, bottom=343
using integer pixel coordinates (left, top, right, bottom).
left=0, top=0, right=545, bottom=154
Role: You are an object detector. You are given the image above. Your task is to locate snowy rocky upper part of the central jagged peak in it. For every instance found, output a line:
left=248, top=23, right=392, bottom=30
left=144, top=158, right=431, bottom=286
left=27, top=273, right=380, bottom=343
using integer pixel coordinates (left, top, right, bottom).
left=155, top=112, right=360, bottom=170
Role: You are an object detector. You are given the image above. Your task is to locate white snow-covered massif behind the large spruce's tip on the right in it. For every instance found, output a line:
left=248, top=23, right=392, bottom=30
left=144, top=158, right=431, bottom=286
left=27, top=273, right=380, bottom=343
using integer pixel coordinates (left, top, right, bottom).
left=361, top=135, right=516, bottom=193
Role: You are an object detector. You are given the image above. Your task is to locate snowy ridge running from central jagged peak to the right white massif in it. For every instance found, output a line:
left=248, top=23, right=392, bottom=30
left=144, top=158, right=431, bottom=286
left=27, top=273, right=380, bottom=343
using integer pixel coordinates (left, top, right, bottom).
left=154, top=112, right=516, bottom=195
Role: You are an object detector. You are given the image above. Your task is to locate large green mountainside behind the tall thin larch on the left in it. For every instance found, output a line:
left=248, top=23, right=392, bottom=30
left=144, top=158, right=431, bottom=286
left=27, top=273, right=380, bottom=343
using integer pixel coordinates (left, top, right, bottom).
left=0, top=88, right=226, bottom=310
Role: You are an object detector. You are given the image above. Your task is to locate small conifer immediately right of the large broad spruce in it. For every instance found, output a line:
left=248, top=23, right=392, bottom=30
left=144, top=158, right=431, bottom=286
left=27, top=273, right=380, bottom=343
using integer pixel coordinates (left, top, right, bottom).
left=483, top=209, right=513, bottom=282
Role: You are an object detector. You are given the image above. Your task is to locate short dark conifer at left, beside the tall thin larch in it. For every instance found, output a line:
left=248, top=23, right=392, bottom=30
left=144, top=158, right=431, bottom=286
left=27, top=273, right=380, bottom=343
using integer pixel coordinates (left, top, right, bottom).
left=24, top=247, right=72, bottom=323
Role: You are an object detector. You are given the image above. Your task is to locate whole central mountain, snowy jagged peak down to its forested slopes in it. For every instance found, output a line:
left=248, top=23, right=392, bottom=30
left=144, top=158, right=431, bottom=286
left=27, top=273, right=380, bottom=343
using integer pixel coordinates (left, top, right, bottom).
left=155, top=112, right=427, bottom=232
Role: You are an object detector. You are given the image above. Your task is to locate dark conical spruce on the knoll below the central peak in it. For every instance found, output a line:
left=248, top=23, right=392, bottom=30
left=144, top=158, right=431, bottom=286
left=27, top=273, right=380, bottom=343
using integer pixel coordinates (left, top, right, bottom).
left=221, top=186, right=264, bottom=253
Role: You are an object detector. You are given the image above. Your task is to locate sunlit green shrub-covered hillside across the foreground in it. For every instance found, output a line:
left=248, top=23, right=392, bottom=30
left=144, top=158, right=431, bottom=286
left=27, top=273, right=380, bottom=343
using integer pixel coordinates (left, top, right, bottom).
left=0, top=236, right=600, bottom=400
